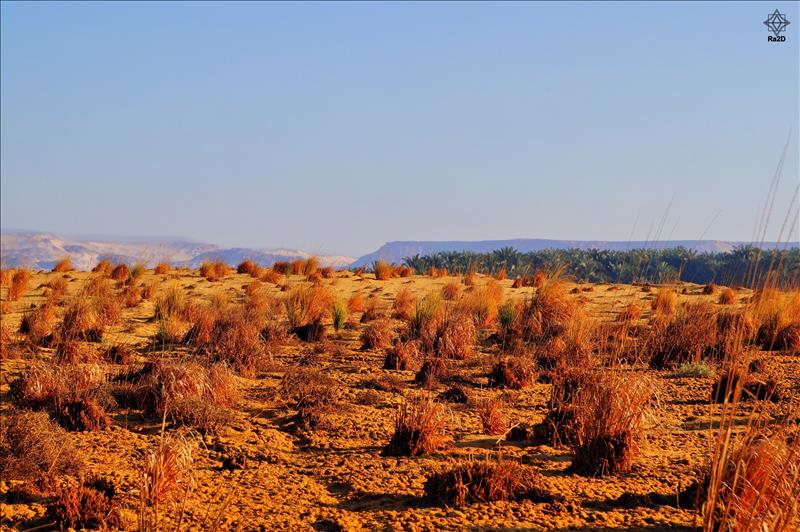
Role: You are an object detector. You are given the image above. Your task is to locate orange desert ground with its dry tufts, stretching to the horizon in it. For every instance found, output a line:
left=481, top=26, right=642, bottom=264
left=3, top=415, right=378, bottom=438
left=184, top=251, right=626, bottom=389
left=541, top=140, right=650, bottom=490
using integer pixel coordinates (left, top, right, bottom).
left=0, top=267, right=800, bottom=530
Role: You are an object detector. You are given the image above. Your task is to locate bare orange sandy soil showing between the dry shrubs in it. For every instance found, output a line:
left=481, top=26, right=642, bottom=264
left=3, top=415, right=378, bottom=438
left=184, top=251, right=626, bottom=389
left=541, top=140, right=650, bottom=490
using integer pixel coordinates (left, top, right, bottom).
left=0, top=271, right=800, bottom=530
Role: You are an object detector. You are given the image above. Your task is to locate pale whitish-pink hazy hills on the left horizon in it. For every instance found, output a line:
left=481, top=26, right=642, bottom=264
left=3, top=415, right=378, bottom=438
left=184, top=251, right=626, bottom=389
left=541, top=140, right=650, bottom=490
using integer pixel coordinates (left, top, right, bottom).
left=0, top=231, right=353, bottom=270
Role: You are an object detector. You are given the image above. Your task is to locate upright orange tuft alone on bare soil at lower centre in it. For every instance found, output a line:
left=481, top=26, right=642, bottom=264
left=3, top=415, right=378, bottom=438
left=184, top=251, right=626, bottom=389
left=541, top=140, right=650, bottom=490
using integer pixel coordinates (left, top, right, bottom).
left=383, top=398, right=446, bottom=456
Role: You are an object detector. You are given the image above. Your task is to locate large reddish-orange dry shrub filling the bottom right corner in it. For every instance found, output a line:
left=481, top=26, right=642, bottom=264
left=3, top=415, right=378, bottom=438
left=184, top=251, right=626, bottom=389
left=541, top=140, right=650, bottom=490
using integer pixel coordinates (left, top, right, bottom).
left=702, top=426, right=800, bottom=531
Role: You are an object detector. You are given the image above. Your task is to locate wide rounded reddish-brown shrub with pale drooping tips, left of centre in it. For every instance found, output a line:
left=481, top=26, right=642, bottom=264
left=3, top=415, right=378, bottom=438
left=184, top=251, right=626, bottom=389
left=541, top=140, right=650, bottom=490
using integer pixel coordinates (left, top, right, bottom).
left=131, top=362, right=239, bottom=433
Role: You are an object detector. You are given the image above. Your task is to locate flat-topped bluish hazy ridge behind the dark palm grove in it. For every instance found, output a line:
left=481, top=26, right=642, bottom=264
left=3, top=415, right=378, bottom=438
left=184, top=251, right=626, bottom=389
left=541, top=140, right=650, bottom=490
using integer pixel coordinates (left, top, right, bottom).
left=352, top=238, right=798, bottom=266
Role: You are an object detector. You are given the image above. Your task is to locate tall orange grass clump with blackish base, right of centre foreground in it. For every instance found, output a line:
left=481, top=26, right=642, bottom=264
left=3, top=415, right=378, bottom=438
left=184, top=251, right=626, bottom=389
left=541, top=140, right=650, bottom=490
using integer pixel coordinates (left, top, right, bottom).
left=570, top=373, right=653, bottom=476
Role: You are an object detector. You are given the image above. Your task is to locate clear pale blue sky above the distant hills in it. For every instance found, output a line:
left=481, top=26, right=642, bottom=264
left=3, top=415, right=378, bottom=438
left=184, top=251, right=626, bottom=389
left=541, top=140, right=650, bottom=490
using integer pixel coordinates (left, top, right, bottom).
left=0, top=2, right=800, bottom=256
